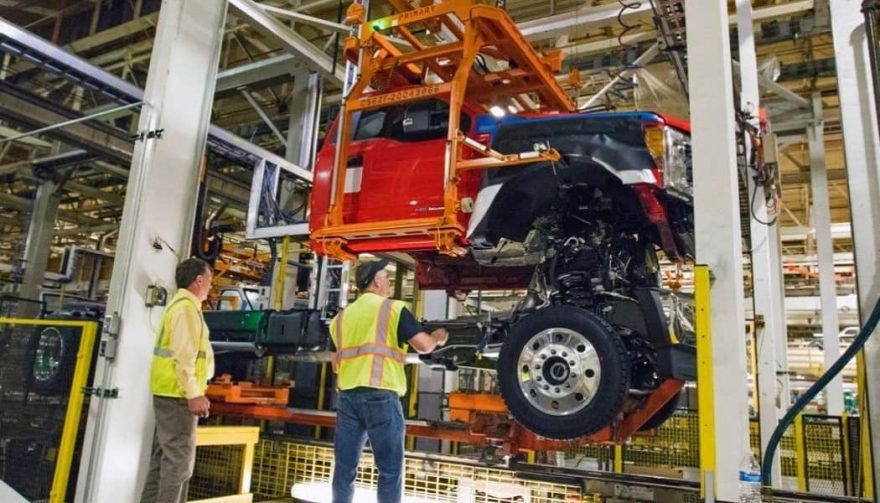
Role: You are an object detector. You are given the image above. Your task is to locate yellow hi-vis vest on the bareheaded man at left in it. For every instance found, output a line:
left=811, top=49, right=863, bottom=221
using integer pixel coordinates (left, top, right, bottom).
left=150, top=289, right=213, bottom=398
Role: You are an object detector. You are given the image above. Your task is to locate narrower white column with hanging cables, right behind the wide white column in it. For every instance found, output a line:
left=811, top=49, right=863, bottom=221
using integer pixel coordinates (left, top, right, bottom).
left=736, top=0, right=787, bottom=487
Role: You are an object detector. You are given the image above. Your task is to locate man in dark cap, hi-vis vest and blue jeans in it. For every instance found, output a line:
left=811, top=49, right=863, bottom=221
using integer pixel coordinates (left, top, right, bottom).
left=330, top=260, right=449, bottom=503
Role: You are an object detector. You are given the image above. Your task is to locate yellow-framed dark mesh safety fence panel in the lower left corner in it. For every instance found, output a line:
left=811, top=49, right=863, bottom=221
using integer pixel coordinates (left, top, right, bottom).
left=0, top=318, right=98, bottom=503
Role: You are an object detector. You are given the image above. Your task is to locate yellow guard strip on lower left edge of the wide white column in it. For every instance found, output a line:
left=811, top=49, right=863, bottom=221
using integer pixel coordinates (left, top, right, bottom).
left=694, top=265, right=715, bottom=501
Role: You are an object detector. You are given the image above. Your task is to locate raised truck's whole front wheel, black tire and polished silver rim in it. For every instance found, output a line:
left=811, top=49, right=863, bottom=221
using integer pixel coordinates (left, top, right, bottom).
left=498, top=306, right=630, bottom=439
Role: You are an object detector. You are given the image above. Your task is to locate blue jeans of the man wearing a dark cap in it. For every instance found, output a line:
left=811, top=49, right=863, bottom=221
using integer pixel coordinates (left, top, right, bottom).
left=333, top=388, right=404, bottom=503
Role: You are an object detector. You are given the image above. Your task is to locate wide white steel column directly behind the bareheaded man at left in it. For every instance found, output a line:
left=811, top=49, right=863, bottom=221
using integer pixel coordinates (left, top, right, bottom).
left=76, top=0, right=226, bottom=502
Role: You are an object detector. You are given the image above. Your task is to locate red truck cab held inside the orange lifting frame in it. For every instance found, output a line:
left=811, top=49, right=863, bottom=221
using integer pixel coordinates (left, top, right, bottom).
left=309, top=99, right=488, bottom=253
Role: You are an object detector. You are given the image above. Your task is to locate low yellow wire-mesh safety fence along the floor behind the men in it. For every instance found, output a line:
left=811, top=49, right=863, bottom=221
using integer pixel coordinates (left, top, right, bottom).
left=190, top=412, right=864, bottom=503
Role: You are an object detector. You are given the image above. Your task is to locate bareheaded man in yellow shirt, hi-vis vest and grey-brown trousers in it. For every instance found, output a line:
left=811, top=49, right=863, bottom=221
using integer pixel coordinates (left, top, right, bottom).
left=141, top=258, right=214, bottom=503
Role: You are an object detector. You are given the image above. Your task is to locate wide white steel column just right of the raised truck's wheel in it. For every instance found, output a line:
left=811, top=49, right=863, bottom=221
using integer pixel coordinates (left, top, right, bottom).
left=685, top=0, right=749, bottom=501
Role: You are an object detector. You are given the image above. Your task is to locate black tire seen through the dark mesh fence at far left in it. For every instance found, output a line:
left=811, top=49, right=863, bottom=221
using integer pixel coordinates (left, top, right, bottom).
left=25, top=326, right=80, bottom=395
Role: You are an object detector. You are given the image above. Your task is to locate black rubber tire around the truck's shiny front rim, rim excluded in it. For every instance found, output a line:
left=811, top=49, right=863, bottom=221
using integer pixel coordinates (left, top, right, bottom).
left=498, top=306, right=630, bottom=439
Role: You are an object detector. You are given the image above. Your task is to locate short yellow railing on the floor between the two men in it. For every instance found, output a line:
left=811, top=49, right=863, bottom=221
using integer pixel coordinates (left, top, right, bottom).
left=190, top=426, right=260, bottom=503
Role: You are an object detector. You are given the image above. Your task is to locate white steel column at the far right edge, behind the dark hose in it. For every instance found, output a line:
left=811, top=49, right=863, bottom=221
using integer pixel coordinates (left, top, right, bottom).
left=828, top=0, right=880, bottom=501
